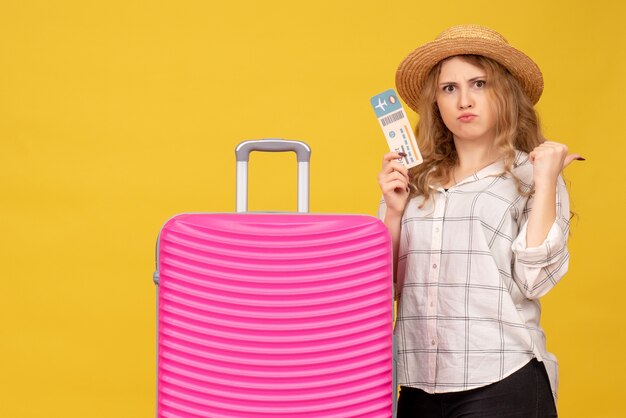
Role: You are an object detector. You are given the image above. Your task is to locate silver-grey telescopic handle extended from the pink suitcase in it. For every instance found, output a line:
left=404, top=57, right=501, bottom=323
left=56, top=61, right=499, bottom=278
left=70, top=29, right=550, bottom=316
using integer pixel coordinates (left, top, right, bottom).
left=235, top=139, right=311, bottom=212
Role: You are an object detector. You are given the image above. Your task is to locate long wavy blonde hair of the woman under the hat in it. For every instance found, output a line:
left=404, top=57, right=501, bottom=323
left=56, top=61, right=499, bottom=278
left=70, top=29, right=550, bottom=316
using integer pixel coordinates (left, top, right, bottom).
left=409, top=55, right=545, bottom=205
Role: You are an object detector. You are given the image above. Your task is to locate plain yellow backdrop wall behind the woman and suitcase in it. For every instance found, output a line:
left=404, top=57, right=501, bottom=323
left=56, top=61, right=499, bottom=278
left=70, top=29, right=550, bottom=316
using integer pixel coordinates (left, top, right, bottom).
left=0, top=0, right=626, bottom=418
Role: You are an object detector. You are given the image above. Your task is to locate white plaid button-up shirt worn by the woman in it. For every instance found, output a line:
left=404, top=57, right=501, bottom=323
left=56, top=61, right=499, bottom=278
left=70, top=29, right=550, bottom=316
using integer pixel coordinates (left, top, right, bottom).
left=379, top=152, right=569, bottom=398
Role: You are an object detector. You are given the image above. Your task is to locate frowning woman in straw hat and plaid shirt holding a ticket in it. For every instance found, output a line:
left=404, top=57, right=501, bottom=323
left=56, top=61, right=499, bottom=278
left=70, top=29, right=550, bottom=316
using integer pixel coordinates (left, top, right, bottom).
left=378, top=25, right=582, bottom=418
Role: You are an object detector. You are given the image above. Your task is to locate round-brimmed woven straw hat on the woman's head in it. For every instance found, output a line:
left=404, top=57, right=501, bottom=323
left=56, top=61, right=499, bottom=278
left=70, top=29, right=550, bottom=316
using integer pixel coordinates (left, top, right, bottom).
left=396, top=25, right=543, bottom=111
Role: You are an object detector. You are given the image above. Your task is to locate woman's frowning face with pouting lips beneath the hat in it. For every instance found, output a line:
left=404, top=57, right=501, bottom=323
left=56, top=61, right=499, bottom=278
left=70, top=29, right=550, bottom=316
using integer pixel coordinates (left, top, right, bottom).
left=436, top=57, right=496, bottom=143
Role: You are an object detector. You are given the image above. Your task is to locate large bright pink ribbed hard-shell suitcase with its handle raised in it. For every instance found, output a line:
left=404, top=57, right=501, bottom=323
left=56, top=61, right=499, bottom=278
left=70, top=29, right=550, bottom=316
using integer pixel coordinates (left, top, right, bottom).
left=154, top=140, right=393, bottom=418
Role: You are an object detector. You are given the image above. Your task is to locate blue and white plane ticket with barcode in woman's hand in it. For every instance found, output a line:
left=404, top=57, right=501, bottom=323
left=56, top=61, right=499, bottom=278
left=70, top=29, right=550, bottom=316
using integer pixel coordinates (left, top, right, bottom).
left=370, top=89, right=424, bottom=168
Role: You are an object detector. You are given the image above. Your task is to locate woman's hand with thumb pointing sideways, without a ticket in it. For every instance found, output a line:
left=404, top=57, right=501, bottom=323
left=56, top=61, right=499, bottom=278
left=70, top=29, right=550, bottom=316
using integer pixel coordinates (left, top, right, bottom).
left=529, top=141, right=584, bottom=187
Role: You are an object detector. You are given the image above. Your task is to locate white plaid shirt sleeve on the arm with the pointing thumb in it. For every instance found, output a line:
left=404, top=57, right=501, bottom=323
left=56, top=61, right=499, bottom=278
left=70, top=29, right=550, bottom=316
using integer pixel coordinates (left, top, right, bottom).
left=512, top=176, right=570, bottom=299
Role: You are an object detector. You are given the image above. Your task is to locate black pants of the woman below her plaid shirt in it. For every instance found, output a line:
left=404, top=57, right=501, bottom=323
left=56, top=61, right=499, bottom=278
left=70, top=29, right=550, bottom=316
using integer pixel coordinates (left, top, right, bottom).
left=398, top=359, right=557, bottom=418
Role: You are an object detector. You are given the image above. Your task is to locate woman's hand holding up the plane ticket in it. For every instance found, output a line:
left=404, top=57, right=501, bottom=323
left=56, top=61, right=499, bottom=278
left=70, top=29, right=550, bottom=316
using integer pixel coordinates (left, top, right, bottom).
left=378, top=152, right=409, bottom=215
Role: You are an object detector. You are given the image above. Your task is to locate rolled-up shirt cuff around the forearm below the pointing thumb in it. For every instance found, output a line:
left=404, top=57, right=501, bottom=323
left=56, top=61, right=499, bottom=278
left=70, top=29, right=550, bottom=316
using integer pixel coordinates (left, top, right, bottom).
left=512, top=221, right=565, bottom=267
